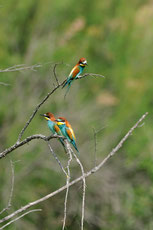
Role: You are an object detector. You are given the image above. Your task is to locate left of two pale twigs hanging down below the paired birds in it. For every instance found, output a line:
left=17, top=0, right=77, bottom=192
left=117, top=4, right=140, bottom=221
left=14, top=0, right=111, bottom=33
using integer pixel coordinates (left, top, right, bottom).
left=62, top=140, right=72, bottom=230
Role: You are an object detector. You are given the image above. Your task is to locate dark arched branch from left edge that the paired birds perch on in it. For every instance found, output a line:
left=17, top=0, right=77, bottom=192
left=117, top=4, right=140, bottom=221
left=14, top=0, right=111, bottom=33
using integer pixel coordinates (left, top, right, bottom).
left=0, top=134, right=64, bottom=159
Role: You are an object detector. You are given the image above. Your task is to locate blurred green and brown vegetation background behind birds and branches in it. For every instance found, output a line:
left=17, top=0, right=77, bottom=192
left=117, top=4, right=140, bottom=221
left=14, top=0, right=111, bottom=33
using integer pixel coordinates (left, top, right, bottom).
left=0, top=0, right=153, bottom=230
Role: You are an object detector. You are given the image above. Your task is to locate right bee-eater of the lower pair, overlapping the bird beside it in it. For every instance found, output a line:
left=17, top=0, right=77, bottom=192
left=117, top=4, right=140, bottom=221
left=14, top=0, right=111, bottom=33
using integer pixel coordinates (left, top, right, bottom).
left=56, top=117, right=79, bottom=152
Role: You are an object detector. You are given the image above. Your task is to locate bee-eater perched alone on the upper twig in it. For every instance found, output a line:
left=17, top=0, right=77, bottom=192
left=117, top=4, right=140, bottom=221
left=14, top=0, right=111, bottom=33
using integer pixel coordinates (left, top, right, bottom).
left=62, top=58, right=87, bottom=96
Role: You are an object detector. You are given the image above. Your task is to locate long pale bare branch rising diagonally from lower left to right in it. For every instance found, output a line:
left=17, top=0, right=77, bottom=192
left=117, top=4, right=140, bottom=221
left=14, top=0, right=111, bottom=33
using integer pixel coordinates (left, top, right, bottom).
left=0, top=112, right=148, bottom=223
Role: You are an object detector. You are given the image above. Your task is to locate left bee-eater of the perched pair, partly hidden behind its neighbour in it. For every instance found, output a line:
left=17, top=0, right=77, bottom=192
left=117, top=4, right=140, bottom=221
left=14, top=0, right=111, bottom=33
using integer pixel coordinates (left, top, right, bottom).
left=40, top=112, right=65, bottom=149
